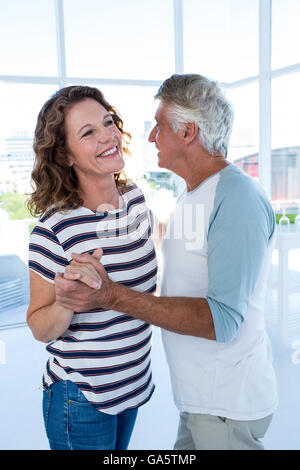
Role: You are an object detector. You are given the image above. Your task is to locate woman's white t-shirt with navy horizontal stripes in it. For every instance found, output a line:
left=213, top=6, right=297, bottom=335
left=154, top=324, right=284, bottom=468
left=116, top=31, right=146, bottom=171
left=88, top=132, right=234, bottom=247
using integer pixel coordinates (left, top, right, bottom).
left=29, top=184, right=157, bottom=414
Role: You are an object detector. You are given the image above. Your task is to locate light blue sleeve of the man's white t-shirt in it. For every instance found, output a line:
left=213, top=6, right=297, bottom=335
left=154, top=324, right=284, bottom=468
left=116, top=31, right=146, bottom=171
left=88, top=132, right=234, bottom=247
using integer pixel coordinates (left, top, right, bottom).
left=206, top=171, right=275, bottom=342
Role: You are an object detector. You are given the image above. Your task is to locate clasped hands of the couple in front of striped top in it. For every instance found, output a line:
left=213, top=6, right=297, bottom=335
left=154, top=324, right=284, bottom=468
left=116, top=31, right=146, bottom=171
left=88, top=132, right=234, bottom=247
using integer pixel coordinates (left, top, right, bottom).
left=54, top=248, right=116, bottom=312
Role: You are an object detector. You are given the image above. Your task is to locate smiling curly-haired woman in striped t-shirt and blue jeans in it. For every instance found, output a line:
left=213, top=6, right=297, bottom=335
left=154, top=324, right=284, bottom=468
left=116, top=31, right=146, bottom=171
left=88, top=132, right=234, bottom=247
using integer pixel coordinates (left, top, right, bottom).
left=27, top=86, right=157, bottom=449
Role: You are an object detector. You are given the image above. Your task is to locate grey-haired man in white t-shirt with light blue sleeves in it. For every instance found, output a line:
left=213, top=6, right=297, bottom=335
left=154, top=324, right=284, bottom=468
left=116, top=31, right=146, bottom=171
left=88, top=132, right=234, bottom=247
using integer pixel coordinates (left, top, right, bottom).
left=56, top=74, right=277, bottom=449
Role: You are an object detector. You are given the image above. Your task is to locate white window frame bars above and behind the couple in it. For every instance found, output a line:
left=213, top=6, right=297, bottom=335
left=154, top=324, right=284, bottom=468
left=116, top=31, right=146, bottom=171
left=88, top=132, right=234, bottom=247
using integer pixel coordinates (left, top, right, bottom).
left=0, top=0, right=300, bottom=197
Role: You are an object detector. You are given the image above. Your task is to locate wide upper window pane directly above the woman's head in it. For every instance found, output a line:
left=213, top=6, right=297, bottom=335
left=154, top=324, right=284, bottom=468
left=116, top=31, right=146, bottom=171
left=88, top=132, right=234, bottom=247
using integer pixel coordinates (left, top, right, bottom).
left=64, top=0, right=174, bottom=79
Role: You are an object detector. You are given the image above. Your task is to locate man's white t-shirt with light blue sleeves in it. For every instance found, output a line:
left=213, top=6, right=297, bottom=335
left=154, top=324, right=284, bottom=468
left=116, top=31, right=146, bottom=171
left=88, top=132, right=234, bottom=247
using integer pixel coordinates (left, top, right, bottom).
left=161, top=165, right=277, bottom=420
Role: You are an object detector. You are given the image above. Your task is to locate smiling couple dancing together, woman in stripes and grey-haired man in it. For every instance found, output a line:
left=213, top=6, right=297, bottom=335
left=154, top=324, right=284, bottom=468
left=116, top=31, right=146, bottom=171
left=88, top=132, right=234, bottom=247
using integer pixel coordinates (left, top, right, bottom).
left=27, top=74, right=277, bottom=450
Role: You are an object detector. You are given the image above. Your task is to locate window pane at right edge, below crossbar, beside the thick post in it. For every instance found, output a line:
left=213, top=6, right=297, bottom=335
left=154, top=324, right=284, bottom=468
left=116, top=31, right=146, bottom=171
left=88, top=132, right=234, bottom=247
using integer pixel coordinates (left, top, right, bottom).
left=272, top=73, right=300, bottom=206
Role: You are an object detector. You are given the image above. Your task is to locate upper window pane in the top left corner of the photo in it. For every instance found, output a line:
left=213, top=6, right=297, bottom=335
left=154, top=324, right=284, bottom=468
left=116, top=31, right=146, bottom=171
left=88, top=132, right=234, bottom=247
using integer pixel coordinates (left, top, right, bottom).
left=0, top=0, right=57, bottom=76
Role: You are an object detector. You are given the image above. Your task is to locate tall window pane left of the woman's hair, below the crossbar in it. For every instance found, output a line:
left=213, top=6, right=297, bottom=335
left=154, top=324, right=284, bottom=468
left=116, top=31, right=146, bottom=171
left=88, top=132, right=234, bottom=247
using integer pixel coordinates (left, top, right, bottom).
left=0, top=82, right=55, bottom=326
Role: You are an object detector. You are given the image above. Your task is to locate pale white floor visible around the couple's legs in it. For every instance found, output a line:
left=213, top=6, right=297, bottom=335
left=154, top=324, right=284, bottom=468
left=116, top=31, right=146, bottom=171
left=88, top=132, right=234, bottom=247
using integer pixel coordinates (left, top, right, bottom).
left=0, top=318, right=300, bottom=450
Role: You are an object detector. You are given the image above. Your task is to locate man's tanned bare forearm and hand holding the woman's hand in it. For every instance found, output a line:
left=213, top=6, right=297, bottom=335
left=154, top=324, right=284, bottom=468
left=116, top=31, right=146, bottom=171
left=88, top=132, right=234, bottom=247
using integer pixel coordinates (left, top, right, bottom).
left=55, top=254, right=216, bottom=340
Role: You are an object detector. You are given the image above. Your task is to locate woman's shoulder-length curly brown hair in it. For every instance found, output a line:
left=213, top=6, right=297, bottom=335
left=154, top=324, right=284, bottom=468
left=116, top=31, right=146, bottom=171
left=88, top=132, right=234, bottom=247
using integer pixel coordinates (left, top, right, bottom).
left=27, top=86, right=131, bottom=217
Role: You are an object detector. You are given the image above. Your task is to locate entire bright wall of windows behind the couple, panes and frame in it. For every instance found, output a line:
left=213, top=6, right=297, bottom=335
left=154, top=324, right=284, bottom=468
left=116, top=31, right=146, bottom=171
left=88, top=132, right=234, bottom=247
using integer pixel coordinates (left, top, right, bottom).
left=0, top=0, right=300, bottom=326
